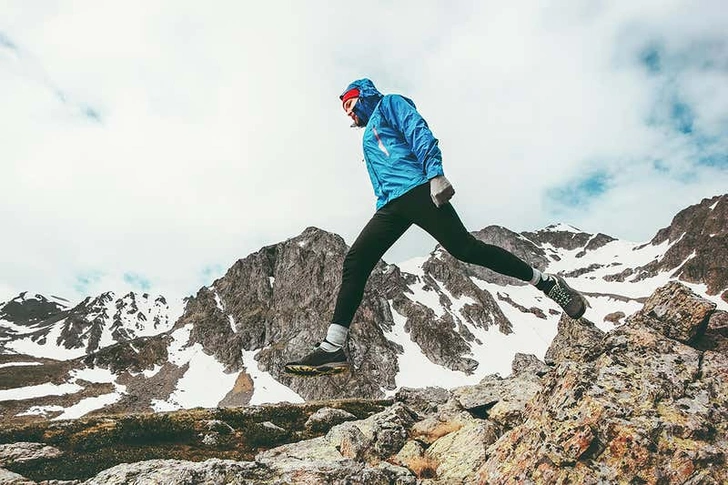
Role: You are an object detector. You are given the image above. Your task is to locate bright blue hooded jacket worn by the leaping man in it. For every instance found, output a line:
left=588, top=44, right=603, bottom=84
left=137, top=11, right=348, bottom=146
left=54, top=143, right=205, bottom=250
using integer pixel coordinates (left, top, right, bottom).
left=344, top=79, right=444, bottom=209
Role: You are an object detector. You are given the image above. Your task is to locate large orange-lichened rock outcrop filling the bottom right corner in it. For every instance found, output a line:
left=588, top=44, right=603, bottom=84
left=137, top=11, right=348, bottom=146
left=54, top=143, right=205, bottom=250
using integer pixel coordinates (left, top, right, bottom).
left=479, top=282, right=728, bottom=484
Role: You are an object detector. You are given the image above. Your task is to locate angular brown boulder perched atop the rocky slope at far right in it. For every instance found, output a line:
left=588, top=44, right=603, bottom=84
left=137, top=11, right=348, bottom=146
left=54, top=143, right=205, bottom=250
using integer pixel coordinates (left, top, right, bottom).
left=627, top=281, right=716, bottom=342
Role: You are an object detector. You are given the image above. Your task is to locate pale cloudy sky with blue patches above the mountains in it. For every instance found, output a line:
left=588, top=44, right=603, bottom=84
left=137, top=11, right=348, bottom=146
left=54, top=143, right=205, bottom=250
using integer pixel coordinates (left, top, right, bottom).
left=0, top=0, right=728, bottom=301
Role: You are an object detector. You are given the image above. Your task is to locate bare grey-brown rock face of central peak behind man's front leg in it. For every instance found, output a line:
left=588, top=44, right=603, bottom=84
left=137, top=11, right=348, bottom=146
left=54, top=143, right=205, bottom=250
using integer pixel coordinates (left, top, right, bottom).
left=175, top=228, right=511, bottom=399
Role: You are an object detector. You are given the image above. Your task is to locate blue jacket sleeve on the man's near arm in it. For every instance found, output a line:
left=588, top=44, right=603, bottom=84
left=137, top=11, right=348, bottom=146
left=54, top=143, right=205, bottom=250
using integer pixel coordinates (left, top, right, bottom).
left=381, top=94, right=444, bottom=180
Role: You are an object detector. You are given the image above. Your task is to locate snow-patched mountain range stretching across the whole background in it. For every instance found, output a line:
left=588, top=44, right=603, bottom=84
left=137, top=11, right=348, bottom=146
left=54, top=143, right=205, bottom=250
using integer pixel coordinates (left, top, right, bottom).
left=0, top=194, right=728, bottom=419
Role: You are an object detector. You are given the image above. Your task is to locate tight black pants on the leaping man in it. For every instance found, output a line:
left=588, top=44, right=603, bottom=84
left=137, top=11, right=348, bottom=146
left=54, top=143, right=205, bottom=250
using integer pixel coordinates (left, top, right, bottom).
left=332, top=183, right=533, bottom=327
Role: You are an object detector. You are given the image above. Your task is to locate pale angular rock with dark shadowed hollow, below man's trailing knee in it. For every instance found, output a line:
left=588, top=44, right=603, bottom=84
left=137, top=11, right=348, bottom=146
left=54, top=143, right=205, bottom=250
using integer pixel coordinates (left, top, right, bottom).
left=453, top=374, right=542, bottom=428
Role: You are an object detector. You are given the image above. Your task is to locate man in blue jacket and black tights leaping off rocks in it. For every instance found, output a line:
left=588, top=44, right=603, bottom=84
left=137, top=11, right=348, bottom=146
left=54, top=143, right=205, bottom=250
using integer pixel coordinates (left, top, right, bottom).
left=285, top=79, right=586, bottom=375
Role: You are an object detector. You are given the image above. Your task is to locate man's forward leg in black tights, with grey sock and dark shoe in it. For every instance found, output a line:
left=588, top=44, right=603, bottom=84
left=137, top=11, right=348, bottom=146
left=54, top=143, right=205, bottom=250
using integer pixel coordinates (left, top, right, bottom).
left=284, top=201, right=411, bottom=375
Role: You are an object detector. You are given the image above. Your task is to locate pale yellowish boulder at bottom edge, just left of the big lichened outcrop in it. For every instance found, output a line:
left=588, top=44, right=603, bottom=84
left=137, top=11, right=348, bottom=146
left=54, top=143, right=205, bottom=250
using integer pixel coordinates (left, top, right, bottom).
left=425, top=420, right=500, bottom=484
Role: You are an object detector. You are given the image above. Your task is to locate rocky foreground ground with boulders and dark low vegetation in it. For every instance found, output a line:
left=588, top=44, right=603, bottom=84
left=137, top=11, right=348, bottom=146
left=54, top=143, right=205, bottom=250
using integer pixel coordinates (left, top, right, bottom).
left=0, top=282, right=728, bottom=485
